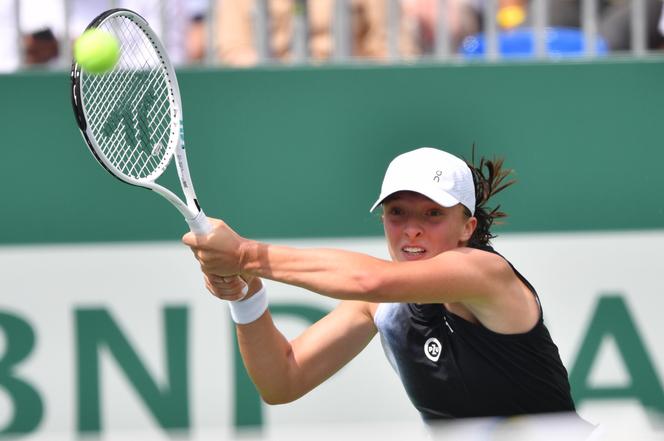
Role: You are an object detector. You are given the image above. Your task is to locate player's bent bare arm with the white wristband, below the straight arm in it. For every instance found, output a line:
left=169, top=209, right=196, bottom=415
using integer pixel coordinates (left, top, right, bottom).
left=223, top=279, right=377, bottom=404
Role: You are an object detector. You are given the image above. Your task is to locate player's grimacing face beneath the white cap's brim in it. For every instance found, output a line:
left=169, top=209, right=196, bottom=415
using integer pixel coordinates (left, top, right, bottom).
left=383, top=191, right=477, bottom=261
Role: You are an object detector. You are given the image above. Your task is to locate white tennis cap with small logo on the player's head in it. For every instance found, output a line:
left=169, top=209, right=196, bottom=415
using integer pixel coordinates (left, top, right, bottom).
left=369, top=147, right=475, bottom=214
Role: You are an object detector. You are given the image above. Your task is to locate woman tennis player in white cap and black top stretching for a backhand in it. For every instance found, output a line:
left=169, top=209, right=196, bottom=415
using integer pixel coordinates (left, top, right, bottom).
left=183, top=148, right=574, bottom=420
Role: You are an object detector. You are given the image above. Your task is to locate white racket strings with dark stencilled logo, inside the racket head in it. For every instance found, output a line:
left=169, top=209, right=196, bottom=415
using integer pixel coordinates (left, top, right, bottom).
left=82, top=16, right=177, bottom=179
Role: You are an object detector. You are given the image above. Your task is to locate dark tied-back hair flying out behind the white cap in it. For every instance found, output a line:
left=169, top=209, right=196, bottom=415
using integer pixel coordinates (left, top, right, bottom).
left=465, top=149, right=516, bottom=248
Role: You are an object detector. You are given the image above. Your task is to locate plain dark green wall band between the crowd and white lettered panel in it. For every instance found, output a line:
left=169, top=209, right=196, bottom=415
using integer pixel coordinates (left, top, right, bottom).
left=0, top=60, right=664, bottom=244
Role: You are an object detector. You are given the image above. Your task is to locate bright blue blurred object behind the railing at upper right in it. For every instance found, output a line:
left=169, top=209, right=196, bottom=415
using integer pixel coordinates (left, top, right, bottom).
left=460, top=28, right=608, bottom=58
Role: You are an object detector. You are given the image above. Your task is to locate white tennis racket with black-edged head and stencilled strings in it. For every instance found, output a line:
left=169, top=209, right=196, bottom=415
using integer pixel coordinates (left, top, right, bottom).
left=71, top=9, right=246, bottom=293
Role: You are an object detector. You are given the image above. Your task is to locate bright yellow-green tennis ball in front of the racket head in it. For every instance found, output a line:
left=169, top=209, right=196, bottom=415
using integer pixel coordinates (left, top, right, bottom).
left=74, top=28, right=120, bottom=74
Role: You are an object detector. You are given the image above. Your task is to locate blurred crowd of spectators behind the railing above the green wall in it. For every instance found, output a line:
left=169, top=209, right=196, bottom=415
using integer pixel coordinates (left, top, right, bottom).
left=0, top=0, right=664, bottom=72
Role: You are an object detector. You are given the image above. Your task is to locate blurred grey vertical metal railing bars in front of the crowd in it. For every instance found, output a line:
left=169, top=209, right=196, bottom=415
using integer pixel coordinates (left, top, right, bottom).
left=0, top=0, right=651, bottom=72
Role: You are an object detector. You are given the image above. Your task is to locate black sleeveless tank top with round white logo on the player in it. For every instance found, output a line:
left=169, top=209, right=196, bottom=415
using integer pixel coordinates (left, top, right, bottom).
left=374, top=247, right=574, bottom=420
